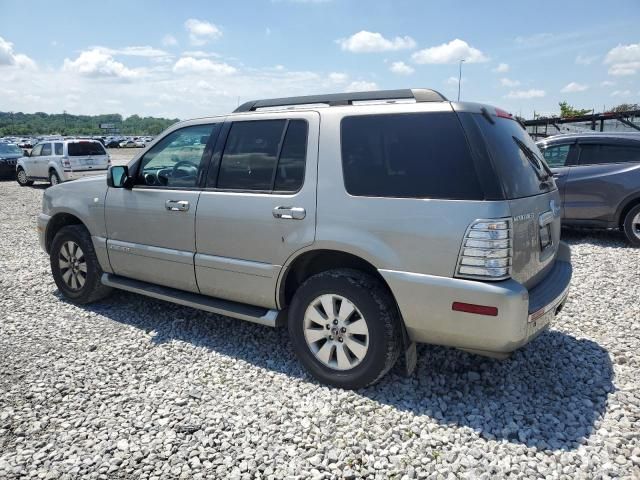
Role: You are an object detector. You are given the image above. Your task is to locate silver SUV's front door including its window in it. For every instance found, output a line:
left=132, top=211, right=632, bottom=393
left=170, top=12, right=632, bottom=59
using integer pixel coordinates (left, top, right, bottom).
left=105, top=123, right=217, bottom=292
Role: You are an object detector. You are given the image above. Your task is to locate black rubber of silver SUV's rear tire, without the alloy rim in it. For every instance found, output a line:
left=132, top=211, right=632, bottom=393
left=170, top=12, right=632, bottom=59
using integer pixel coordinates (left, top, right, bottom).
left=288, top=269, right=402, bottom=389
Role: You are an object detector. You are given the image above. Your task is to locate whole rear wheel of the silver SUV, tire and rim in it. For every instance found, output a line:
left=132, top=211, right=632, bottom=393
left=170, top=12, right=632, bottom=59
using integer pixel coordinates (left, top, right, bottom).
left=288, top=269, right=402, bottom=389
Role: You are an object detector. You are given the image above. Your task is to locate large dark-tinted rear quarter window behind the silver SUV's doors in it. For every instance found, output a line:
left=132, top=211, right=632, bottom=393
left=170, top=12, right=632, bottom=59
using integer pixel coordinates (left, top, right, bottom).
left=341, top=112, right=484, bottom=200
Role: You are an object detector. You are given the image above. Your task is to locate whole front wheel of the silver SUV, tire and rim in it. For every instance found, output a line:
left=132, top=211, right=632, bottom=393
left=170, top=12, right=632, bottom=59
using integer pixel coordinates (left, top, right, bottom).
left=49, top=225, right=112, bottom=305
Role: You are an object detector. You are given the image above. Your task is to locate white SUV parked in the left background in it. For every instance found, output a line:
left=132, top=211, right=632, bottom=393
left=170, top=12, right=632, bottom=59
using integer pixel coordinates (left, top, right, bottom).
left=16, top=140, right=111, bottom=187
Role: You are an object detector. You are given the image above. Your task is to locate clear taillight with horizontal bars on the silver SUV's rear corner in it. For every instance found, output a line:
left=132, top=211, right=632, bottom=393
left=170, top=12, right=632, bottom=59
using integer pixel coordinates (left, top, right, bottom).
left=456, top=219, right=512, bottom=280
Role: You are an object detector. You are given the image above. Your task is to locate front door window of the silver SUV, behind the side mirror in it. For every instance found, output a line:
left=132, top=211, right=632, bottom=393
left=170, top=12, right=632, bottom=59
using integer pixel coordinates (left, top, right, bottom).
left=136, top=124, right=216, bottom=188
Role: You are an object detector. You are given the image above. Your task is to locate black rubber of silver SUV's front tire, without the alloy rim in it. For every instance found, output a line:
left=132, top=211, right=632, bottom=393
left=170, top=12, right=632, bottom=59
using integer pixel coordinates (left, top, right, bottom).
left=49, top=225, right=112, bottom=305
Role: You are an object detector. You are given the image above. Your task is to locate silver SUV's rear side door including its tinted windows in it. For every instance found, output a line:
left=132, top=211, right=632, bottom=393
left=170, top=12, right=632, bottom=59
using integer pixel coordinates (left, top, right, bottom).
left=195, top=112, right=320, bottom=308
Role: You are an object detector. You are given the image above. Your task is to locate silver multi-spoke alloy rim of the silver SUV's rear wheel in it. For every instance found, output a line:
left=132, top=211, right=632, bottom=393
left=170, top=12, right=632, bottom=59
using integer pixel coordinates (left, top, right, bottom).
left=304, top=294, right=369, bottom=370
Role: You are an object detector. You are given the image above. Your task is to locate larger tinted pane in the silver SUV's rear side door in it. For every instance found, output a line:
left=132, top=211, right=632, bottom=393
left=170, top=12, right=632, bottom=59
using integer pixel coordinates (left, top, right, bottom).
left=217, top=120, right=287, bottom=190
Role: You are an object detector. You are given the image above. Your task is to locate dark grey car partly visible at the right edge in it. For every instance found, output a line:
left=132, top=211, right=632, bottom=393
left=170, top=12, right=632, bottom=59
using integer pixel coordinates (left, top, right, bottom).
left=538, top=133, right=640, bottom=247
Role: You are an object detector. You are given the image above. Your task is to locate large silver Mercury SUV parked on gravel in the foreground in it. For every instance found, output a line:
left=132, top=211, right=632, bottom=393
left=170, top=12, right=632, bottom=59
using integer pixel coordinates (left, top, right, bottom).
left=38, top=89, right=572, bottom=388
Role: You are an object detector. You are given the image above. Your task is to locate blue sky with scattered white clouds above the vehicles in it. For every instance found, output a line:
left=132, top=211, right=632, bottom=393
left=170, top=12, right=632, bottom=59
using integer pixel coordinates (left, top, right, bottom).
left=0, top=0, right=640, bottom=119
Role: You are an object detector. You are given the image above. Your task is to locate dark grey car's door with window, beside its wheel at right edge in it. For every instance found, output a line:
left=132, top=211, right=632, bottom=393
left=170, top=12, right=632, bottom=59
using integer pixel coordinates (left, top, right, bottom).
left=565, top=138, right=640, bottom=222
